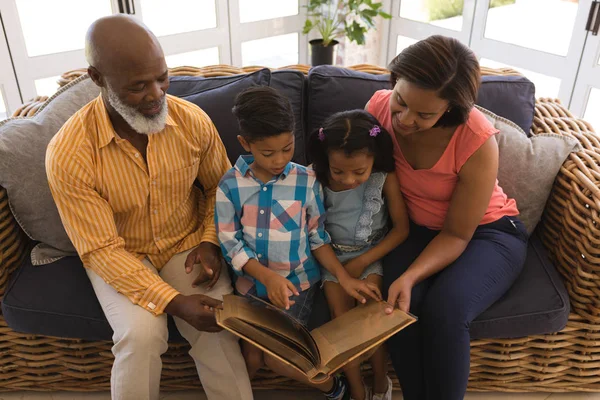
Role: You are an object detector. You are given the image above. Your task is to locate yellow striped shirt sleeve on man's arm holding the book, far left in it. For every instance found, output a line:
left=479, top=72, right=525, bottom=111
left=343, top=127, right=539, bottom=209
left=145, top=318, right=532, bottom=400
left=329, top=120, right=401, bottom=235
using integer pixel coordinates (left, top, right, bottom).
left=46, top=144, right=178, bottom=315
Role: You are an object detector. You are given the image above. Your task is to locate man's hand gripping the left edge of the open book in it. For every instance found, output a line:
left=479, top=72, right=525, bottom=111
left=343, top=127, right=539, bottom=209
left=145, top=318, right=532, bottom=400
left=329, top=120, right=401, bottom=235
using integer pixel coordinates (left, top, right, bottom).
left=165, top=294, right=223, bottom=332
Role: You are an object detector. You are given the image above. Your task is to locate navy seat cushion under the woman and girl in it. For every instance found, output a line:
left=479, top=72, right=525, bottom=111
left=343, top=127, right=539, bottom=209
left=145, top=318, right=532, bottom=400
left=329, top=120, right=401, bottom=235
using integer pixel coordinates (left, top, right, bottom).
left=309, top=228, right=570, bottom=339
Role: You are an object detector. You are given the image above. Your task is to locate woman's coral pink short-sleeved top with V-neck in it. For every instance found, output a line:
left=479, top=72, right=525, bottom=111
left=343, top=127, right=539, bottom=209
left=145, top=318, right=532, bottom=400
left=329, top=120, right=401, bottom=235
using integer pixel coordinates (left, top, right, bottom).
left=368, top=90, right=519, bottom=230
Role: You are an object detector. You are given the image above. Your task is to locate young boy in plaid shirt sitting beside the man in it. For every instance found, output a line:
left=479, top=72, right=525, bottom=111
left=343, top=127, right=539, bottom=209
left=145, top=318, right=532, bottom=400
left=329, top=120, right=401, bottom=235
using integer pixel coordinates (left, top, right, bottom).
left=215, top=86, right=381, bottom=399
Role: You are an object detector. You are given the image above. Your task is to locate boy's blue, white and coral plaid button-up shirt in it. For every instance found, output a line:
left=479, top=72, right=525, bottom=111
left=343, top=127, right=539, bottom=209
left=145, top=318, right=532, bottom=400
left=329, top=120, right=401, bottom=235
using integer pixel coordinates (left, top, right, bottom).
left=215, top=156, right=331, bottom=297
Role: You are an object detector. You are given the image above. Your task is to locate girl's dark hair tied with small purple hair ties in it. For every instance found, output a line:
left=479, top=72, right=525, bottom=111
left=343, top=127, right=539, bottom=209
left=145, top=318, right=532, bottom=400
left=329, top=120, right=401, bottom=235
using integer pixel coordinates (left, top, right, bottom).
left=308, top=110, right=395, bottom=186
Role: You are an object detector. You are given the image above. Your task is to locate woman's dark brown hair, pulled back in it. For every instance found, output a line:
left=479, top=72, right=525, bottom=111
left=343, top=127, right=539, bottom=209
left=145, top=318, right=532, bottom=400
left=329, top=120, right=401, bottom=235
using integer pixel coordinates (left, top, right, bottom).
left=388, top=35, right=481, bottom=126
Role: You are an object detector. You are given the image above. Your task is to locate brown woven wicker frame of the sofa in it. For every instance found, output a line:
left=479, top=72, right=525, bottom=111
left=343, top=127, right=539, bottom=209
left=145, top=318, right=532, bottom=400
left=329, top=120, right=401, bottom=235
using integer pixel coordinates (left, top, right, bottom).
left=0, top=65, right=600, bottom=392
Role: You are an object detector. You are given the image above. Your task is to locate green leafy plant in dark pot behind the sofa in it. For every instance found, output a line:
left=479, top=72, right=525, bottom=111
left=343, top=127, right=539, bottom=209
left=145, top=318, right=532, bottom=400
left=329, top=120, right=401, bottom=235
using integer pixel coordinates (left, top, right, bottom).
left=302, top=0, right=392, bottom=66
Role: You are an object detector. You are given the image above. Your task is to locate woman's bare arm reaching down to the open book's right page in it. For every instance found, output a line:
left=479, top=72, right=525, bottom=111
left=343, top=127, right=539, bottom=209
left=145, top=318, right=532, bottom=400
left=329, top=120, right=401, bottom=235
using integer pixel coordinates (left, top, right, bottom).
left=388, top=137, right=498, bottom=311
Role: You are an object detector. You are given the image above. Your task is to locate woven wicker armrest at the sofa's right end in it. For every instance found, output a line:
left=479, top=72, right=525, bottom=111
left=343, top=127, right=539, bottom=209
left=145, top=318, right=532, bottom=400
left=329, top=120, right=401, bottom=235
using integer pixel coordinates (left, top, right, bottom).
left=531, top=99, right=600, bottom=324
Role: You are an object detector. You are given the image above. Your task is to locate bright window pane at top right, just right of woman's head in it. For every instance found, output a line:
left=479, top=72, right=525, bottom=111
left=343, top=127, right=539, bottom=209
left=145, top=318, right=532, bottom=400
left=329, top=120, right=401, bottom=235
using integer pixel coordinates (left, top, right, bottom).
left=485, top=0, right=579, bottom=56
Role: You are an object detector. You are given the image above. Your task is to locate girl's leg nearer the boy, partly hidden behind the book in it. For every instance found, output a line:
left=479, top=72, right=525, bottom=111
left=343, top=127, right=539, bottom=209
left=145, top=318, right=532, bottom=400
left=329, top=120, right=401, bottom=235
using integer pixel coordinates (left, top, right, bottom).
left=323, top=281, right=366, bottom=400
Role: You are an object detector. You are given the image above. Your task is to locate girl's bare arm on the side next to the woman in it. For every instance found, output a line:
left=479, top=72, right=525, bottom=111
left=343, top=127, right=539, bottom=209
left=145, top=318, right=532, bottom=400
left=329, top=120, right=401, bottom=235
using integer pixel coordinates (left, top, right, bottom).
left=345, top=172, right=409, bottom=278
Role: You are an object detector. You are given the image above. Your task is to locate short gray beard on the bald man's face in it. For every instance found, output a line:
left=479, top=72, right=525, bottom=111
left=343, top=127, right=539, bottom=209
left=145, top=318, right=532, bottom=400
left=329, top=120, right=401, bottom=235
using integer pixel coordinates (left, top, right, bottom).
left=106, top=87, right=169, bottom=135
